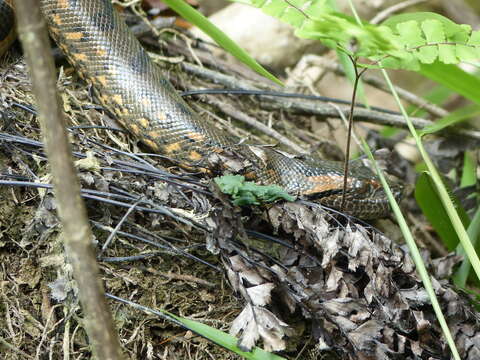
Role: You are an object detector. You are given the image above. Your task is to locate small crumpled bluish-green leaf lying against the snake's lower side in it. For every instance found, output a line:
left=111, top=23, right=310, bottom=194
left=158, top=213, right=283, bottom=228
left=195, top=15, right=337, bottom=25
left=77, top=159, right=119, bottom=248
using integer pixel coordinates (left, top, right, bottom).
left=215, top=175, right=295, bottom=206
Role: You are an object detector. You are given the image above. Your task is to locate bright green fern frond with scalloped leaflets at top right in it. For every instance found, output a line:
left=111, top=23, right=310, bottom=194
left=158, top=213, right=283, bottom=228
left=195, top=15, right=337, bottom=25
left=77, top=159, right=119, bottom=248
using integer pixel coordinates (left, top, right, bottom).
left=229, top=0, right=480, bottom=70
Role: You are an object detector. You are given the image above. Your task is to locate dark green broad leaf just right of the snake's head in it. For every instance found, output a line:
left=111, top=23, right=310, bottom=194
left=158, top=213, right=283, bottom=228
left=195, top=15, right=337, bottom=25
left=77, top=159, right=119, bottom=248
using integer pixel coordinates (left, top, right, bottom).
left=415, top=172, right=470, bottom=251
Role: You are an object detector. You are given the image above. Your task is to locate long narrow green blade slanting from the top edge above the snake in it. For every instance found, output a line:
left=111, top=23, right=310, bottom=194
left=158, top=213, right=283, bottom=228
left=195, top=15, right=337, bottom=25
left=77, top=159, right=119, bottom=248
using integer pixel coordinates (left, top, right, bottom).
left=163, top=0, right=283, bottom=85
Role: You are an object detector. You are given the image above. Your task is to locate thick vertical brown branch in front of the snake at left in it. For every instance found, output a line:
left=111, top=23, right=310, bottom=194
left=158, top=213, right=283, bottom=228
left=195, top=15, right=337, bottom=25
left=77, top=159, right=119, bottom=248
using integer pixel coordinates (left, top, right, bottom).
left=14, top=0, right=122, bottom=360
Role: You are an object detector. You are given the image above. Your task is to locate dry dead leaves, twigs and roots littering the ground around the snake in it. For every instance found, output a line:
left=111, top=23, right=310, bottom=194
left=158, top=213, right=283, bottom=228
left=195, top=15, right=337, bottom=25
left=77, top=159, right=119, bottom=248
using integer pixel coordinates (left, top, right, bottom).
left=0, top=3, right=480, bottom=359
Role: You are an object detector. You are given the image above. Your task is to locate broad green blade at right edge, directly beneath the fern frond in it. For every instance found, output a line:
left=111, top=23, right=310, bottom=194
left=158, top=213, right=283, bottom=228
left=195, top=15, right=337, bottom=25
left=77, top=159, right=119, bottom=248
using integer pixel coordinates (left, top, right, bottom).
left=420, top=62, right=480, bottom=104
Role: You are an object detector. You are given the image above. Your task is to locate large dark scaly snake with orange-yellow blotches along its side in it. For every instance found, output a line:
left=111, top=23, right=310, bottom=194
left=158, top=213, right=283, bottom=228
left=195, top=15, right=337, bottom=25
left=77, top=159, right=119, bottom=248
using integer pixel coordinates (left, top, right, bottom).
left=0, top=0, right=403, bottom=219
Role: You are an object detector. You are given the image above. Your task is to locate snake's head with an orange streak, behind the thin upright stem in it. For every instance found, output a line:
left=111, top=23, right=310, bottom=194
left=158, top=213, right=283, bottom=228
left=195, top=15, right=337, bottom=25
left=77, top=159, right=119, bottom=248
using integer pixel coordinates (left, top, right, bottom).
left=253, top=149, right=403, bottom=219
